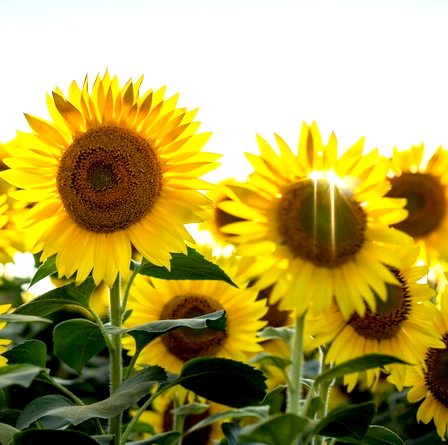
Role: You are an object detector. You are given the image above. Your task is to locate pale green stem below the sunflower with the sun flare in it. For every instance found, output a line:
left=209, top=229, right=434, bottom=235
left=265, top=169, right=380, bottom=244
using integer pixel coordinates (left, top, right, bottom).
left=286, top=314, right=305, bottom=415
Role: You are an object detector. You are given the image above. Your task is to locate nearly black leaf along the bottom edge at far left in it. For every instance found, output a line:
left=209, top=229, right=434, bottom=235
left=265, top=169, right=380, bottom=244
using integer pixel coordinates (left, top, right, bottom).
left=11, top=430, right=103, bottom=445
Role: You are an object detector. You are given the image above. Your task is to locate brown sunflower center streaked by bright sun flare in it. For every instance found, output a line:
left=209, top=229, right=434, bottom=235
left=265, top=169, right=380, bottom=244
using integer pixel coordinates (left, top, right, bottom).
left=277, top=179, right=367, bottom=268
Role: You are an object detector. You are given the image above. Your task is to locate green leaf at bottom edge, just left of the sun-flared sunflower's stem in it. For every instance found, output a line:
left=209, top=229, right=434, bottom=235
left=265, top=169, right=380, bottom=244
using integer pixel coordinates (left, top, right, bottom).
left=238, top=414, right=309, bottom=445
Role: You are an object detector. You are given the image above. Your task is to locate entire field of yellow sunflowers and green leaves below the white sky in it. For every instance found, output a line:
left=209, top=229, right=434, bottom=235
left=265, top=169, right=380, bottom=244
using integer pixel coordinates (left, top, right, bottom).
left=0, top=71, right=448, bottom=445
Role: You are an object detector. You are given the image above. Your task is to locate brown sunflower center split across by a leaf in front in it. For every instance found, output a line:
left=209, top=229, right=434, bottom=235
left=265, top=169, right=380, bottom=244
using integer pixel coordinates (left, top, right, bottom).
left=160, top=294, right=227, bottom=362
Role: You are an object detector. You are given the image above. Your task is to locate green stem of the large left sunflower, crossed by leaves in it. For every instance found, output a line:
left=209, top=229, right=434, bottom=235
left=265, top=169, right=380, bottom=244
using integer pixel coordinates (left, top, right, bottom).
left=109, top=274, right=123, bottom=445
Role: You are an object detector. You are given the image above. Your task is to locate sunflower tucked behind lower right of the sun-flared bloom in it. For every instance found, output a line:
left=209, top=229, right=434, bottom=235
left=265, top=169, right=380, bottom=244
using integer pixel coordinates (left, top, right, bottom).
left=307, top=246, right=443, bottom=391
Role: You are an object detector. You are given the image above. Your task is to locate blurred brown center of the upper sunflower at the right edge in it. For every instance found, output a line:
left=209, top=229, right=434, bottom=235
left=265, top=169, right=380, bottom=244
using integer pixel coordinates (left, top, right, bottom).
left=386, top=172, right=446, bottom=238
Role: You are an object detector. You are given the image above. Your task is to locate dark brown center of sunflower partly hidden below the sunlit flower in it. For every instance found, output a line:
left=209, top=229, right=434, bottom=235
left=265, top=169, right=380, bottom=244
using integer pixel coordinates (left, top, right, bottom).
left=348, top=267, right=411, bottom=341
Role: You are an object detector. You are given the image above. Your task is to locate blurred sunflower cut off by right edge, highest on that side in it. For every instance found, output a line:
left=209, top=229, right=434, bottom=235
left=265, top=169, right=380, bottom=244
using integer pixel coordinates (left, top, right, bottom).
left=386, top=144, right=448, bottom=266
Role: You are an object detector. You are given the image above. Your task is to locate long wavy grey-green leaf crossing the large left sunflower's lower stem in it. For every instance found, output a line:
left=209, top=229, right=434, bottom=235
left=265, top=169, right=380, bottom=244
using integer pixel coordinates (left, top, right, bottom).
left=18, top=366, right=166, bottom=428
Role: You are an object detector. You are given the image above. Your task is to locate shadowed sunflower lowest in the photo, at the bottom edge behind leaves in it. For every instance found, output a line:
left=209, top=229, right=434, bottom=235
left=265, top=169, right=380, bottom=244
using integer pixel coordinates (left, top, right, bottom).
left=133, top=388, right=224, bottom=445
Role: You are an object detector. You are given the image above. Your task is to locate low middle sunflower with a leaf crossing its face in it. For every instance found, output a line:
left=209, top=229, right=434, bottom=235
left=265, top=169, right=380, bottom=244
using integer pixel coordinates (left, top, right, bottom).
left=123, top=276, right=266, bottom=373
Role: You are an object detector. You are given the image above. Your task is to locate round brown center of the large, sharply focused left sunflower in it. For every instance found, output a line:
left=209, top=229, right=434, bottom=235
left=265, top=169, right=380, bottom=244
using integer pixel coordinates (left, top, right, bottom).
left=56, top=126, right=162, bottom=233
